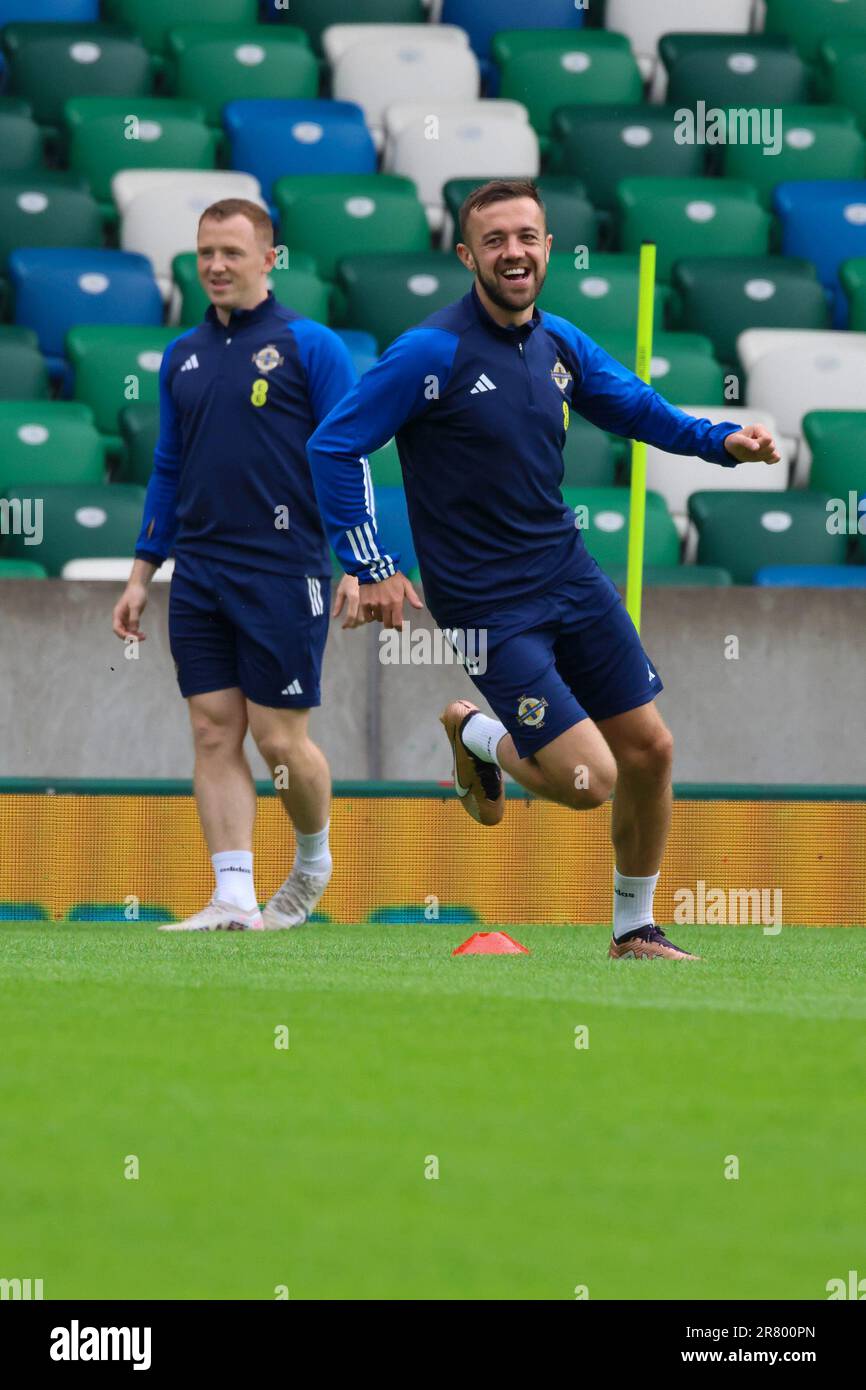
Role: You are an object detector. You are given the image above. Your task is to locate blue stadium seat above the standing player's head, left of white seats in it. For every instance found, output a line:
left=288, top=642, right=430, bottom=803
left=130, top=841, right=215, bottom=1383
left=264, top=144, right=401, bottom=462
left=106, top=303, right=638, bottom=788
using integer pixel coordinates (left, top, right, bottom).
left=222, top=99, right=377, bottom=200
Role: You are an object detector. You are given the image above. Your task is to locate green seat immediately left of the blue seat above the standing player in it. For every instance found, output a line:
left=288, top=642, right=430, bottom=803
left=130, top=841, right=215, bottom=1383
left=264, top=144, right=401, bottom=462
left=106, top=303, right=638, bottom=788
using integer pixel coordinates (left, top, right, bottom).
left=64, top=96, right=220, bottom=214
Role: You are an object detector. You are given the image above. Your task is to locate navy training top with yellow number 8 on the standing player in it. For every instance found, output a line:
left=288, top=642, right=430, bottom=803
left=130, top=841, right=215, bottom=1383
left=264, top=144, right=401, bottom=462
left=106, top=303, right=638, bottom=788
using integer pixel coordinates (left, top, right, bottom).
left=135, top=293, right=361, bottom=575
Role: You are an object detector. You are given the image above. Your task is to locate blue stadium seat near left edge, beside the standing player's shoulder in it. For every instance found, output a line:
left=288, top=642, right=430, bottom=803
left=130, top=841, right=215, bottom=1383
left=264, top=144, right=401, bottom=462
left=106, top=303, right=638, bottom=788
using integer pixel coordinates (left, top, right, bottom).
left=8, top=247, right=163, bottom=375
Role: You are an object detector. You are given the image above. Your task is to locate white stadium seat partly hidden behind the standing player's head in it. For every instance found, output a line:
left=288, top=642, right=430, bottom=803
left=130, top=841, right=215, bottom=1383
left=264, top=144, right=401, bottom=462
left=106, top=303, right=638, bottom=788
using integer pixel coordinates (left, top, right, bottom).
left=120, top=175, right=265, bottom=299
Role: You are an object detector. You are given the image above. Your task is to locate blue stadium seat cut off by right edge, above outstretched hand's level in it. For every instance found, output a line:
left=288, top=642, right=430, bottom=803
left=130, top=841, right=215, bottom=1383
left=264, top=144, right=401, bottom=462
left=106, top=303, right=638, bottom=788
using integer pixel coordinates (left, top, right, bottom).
left=773, top=179, right=866, bottom=328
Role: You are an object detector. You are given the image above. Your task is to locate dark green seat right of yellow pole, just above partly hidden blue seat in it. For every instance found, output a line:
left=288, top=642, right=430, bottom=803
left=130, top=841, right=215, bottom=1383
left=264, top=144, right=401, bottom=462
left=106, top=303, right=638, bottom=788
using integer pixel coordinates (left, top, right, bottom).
left=688, top=492, right=848, bottom=584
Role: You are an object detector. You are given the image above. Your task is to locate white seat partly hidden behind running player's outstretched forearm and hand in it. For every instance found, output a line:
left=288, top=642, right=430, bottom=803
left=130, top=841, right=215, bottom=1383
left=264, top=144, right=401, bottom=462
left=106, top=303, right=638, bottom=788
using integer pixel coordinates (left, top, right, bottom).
left=646, top=406, right=788, bottom=530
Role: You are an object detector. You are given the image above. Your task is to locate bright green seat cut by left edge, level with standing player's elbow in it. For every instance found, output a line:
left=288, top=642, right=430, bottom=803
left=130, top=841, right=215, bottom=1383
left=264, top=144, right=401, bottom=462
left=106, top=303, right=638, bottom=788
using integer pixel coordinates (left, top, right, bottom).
left=0, top=400, right=106, bottom=492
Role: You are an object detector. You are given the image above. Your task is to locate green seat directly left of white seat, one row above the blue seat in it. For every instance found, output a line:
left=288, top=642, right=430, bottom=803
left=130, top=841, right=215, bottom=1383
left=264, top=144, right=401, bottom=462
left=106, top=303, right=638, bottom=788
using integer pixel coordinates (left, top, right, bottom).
left=168, top=24, right=318, bottom=125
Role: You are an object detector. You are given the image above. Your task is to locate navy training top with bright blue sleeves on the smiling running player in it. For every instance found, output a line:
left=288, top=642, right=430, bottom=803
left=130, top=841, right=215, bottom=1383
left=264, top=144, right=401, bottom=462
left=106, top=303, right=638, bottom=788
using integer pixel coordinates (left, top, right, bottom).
left=307, top=285, right=740, bottom=626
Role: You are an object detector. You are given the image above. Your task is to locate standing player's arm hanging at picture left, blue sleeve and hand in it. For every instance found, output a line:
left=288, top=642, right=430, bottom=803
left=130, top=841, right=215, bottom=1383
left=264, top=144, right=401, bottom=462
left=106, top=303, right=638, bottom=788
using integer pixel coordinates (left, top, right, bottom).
left=111, top=353, right=182, bottom=642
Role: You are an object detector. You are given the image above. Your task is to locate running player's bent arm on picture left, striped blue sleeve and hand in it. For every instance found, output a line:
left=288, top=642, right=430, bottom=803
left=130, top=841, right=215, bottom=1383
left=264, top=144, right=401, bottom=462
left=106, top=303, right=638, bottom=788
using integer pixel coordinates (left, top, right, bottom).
left=307, top=329, right=455, bottom=627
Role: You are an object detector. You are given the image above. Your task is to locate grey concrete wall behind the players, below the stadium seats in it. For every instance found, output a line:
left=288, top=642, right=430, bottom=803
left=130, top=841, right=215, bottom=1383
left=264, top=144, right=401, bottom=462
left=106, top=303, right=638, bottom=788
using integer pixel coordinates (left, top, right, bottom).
left=0, top=581, right=866, bottom=783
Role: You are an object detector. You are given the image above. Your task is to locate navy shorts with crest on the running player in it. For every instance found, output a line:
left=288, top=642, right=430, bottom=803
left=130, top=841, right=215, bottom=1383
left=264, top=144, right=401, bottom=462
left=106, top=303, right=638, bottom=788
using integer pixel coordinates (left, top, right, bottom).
left=467, top=571, right=663, bottom=758
